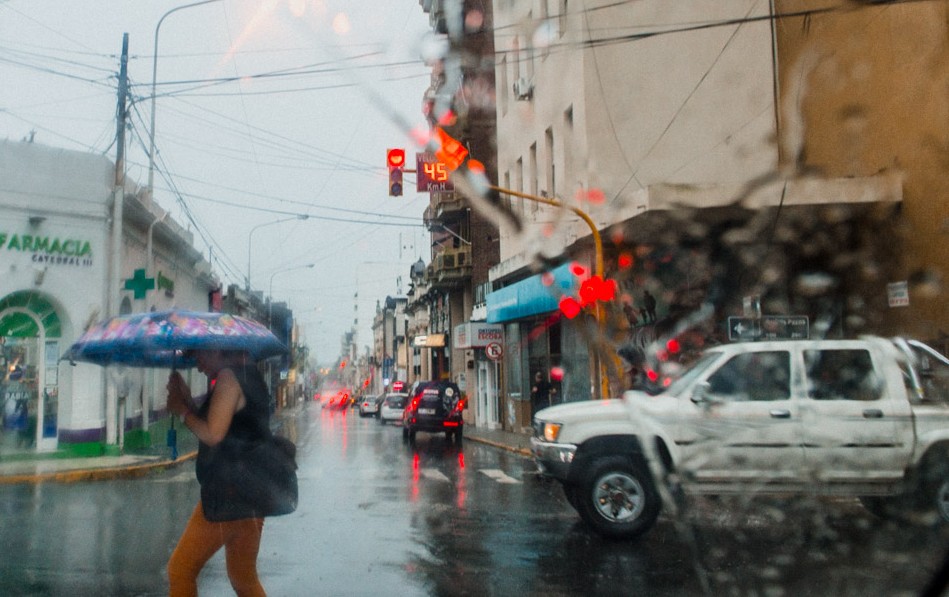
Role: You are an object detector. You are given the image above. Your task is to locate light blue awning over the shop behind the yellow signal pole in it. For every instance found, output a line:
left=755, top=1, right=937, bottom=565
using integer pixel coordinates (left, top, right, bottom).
left=487, top=263, right=579, bottom=323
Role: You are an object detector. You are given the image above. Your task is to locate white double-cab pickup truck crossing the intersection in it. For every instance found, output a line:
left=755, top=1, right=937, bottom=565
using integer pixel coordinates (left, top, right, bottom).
left=531, top=338, right=949, bottom=538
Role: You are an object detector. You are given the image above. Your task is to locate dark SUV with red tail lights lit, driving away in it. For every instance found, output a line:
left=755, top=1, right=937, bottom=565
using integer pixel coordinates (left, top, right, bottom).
left=402, top=381, right=465, bottom=444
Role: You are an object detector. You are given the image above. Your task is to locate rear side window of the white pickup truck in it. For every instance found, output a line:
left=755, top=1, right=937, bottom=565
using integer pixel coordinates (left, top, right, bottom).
left=804, top=349, right=881, bottom=401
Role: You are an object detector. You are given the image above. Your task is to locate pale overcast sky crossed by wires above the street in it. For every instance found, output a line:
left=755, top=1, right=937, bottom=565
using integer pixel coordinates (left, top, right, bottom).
left=0, top=0, right=431, bottom=360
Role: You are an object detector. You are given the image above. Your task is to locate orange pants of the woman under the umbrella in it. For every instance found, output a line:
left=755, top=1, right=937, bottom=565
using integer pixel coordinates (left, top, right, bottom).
left=168, top=501, right=266, bottom=597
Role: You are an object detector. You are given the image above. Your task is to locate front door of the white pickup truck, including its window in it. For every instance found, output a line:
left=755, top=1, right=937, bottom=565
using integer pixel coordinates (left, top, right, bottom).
left=676, top=350, right=804, bottom=485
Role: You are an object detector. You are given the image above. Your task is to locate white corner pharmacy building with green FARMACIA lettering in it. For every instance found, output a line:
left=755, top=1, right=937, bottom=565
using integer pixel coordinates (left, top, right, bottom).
left=0, top=141, right=219, bottom=455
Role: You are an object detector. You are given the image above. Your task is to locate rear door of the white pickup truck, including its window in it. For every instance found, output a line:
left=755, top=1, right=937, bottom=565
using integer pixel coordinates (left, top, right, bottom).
left=801, top=346, right=914, bottom=482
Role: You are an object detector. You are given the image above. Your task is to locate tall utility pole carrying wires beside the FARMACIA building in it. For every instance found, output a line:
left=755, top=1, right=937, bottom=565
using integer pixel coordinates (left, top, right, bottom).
left=102, top=33, right=129, bottom=451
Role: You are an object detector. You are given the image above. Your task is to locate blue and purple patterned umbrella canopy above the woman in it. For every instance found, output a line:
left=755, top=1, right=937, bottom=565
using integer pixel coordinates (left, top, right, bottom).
left=63, top=310, right=287, bottom=369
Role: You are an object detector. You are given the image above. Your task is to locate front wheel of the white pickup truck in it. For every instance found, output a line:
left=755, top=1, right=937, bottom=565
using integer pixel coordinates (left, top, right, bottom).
left=575, top=456, right=661, bottom=539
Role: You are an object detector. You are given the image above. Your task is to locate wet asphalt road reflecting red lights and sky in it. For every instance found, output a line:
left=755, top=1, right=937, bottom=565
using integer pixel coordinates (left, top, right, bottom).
left=0, top=405, right=949, bottom=597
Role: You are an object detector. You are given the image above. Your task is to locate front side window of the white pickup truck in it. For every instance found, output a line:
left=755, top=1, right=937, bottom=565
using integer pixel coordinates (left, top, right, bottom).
left=708, top=351, right=791, bottom=401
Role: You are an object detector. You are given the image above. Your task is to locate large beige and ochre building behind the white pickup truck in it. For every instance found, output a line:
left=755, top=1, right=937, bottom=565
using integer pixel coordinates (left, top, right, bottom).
left=488, top=0, right=949, bottom=423
